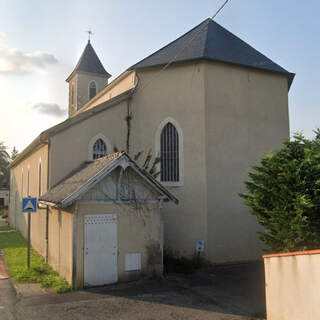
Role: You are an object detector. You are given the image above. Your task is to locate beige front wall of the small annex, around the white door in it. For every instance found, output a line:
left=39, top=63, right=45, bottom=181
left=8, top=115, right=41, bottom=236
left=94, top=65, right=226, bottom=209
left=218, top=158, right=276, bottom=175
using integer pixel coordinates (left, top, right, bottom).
left=75, top=202, right=162, bottom=288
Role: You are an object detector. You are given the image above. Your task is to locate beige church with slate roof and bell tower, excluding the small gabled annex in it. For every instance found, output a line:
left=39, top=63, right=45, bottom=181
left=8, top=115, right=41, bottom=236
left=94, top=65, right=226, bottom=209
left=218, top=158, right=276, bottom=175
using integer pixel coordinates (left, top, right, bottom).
left=9, top=19, right=294, bottom=282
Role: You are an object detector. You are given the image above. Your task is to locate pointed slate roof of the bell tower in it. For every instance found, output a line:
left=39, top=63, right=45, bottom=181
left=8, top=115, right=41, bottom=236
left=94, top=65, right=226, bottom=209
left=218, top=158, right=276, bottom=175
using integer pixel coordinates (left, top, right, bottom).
left=66, top=40, right=111, bottom=81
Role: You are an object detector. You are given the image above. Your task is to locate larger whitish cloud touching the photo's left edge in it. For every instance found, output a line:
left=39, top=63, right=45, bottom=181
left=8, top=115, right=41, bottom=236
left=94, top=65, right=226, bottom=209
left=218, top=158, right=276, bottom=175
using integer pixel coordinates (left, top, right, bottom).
left=0, top=33, right=58, bottom=75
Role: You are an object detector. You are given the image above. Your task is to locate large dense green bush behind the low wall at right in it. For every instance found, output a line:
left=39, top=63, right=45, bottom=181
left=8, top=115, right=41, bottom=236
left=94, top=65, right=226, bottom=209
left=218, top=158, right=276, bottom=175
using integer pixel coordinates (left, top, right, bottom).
left=240, top=130, right=320, bottom=252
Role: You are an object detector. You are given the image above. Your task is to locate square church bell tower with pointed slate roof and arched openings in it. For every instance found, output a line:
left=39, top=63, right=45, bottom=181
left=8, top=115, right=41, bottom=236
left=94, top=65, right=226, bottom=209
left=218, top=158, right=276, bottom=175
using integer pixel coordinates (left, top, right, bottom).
left=66, top=38, right=111, bottom=118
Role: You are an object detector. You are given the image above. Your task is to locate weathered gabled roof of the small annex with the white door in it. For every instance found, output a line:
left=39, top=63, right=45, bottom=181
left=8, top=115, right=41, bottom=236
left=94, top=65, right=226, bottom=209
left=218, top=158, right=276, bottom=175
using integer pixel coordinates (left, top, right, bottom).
left=39, top=152, right=178, bottom=207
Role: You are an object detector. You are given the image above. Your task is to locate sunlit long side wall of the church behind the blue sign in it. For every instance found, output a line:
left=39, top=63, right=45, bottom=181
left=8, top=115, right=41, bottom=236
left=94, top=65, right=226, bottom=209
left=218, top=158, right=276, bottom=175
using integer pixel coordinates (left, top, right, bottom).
left=9, top=145, right=48, bottom=256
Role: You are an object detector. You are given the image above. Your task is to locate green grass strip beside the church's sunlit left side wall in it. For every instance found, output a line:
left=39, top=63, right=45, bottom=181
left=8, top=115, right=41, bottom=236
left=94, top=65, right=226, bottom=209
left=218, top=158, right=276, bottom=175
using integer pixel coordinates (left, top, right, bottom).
left=0, top=232, right=71, bottom=293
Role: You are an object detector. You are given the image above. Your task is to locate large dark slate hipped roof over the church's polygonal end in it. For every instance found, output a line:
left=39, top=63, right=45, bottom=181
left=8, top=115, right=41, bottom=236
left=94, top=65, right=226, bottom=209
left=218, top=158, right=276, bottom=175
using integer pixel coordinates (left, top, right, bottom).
left=130, top=19, right=294, bottom=86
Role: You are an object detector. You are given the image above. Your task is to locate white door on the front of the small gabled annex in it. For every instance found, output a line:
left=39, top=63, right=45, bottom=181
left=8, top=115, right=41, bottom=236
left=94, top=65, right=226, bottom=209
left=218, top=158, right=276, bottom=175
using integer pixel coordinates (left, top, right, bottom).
left=84, top=214, right=118, bottom=286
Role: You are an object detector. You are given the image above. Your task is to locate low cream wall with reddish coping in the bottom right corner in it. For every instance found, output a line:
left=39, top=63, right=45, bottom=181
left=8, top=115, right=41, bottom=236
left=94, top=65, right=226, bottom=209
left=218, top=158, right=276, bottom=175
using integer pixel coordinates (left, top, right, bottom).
left=263, top=250, right=320, bottom=320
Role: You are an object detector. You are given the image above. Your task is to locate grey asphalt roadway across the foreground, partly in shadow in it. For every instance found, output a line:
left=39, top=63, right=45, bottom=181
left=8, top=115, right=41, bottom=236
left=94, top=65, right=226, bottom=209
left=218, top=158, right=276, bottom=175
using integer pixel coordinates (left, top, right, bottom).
left=0, top=265, right=265, bottom=320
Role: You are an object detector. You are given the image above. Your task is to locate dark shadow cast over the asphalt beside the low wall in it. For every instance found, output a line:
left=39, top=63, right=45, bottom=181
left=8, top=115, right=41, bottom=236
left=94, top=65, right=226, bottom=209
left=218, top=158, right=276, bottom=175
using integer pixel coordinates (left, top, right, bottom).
left=83, top=262, right=265, bottom=318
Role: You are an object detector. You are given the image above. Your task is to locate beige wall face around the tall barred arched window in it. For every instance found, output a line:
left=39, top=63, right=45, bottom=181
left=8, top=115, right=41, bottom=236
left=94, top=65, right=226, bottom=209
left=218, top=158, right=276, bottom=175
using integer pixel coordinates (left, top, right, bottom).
left=130, top=63, right=207, bottom=256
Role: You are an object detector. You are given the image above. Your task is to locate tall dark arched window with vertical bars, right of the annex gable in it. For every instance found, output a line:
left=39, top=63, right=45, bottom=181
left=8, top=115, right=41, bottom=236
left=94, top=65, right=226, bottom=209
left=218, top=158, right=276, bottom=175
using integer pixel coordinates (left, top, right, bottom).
left=160, top=122, right=179, bottom=181
